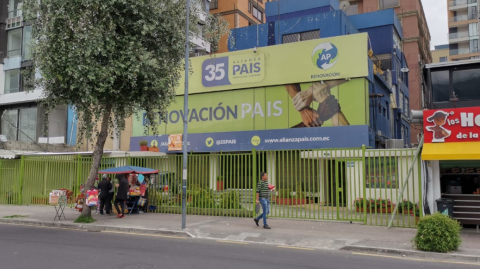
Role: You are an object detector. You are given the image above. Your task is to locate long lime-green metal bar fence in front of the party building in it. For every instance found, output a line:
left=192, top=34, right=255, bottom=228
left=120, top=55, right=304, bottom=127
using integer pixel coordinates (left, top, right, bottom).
left=0, top=148, right=422, bottom=227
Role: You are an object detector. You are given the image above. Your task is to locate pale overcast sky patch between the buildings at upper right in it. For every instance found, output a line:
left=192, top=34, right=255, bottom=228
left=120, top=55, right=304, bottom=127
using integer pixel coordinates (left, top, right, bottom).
left=422, top=0, right=448, bottom=49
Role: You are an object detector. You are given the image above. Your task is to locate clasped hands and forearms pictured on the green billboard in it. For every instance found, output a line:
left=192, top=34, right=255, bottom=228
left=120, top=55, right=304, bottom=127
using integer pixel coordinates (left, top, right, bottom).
left=285, top=80, right=350, bottom=127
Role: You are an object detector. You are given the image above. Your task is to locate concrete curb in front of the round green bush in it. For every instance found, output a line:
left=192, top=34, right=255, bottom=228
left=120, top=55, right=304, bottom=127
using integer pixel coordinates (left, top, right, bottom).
left=340, top=245, right=480, bottom=263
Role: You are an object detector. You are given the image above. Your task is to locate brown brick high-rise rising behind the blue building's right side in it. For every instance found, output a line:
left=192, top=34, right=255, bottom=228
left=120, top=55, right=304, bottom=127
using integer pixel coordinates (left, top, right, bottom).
left=347, top=0, right=432, bottom=144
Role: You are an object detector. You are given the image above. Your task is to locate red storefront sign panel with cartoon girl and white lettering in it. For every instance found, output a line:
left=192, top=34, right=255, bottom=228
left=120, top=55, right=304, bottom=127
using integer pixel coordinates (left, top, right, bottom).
left=423, top=107, right=480, bottom=143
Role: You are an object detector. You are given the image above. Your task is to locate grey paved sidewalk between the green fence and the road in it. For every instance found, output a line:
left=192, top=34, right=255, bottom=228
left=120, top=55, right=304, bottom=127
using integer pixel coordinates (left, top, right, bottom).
left=0, top=205, right=480, bottom=262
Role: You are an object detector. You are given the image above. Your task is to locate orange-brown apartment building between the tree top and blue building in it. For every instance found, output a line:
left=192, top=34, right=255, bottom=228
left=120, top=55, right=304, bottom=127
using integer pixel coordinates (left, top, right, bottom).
left=210, top=0, right=271, bottom=52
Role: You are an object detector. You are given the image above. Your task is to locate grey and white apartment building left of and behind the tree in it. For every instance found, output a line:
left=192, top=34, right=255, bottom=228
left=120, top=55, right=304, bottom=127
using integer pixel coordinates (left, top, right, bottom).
left=0, top=0, right=76, bottom=150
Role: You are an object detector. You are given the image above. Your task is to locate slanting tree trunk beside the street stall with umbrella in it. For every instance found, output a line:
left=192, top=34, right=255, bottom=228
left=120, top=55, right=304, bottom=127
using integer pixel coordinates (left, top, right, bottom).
left=82, top=104, right=112, bottom=217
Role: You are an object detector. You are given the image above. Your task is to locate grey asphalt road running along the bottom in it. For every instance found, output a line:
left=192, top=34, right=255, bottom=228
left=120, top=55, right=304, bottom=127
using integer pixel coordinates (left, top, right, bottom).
left=0, top=224, right=478, bottom=269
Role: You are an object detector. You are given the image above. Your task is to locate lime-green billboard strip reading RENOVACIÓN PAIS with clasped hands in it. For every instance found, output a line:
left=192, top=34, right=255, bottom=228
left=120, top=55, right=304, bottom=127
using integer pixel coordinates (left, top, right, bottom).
left=132, top=78, right=369, bottom=136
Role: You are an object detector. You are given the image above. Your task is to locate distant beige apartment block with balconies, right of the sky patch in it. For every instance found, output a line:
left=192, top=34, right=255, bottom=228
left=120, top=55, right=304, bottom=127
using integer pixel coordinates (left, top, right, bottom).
left=447, top=0, right=480, bottom=61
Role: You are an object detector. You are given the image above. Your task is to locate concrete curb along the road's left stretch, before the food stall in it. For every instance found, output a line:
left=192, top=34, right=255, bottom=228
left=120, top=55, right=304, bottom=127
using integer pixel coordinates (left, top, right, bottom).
left=0, top=218, right=195, bottom=238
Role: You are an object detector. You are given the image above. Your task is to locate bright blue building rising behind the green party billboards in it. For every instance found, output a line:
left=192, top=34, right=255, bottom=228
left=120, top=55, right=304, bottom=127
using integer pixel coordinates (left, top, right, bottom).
left=229, top=0, right=411, bottom=148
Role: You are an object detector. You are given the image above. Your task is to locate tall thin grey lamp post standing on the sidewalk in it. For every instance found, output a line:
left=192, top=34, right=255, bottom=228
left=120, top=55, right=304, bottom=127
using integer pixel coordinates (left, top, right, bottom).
left=182, top=0, right=211, bottom=230
